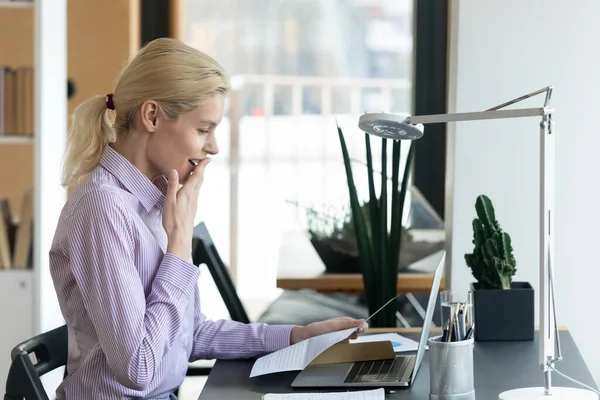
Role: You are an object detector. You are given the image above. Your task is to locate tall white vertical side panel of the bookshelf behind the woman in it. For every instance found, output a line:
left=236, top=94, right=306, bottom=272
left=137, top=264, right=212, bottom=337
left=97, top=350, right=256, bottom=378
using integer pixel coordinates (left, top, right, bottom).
left=34, top=0, right=67, bottom=397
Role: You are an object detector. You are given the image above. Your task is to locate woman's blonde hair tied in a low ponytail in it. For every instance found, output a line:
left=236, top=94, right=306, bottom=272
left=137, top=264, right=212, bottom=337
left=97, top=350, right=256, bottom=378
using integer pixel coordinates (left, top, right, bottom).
left=62, top=38, right=229, bottom=186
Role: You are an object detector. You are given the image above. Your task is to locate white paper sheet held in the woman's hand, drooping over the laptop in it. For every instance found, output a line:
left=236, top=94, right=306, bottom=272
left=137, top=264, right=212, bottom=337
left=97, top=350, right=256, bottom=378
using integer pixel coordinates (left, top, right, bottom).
left=250, top=328, right=356, bottom=378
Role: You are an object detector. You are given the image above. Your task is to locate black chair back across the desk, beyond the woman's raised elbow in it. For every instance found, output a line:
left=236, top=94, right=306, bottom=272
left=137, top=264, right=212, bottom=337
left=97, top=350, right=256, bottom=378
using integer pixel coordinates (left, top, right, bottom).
left=192, top=222, right=250, bottom=324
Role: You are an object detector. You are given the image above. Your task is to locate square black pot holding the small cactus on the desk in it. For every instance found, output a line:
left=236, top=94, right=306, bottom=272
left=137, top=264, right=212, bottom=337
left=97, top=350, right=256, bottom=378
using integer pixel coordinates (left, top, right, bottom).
left=471, top=282, right=535, bottom=341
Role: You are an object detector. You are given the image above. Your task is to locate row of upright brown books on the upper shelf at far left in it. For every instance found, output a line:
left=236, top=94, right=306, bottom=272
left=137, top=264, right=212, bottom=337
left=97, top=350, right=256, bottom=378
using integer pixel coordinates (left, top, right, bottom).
left=0, top=66, right=34, bottom=136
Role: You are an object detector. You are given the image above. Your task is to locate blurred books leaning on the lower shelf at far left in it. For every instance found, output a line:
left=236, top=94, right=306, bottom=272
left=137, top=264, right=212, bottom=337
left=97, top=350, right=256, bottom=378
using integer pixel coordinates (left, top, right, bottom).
left=0, top=188, right=33, bottom=269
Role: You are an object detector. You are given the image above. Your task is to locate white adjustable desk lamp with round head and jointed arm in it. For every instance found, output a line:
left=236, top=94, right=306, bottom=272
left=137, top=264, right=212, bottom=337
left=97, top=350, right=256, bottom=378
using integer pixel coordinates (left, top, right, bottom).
left=358, top=86, right=598, bottom=400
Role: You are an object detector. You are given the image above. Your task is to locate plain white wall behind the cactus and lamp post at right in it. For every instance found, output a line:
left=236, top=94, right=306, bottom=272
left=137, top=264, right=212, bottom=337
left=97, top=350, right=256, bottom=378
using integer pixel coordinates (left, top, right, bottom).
left=446, top=0, right=600, bottom=382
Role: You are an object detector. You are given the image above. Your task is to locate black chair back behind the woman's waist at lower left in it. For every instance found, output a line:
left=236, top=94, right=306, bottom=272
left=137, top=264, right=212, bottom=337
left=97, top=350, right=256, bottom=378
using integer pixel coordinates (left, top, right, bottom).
left=4, top=325, right=68, bottom=400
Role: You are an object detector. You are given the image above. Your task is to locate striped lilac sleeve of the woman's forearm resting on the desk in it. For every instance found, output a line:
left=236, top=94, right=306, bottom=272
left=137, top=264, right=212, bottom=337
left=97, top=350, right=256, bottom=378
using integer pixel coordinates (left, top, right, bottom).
left=189, top=288, right=293, bottom=362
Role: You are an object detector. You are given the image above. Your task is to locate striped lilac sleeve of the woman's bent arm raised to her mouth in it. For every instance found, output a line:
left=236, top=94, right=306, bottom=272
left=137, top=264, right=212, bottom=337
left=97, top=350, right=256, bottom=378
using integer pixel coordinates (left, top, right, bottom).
left=68, top=191, right=199, bottom=390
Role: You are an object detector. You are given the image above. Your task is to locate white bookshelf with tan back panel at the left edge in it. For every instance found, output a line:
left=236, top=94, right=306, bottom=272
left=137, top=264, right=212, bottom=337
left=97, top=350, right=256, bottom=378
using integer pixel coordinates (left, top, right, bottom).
left=0, top=0, right=67, bottom=393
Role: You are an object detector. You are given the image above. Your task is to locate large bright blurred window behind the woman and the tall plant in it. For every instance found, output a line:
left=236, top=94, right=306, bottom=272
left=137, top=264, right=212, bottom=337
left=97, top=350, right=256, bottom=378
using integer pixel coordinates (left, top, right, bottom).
left=171, top=0, right=448, bottom=310
